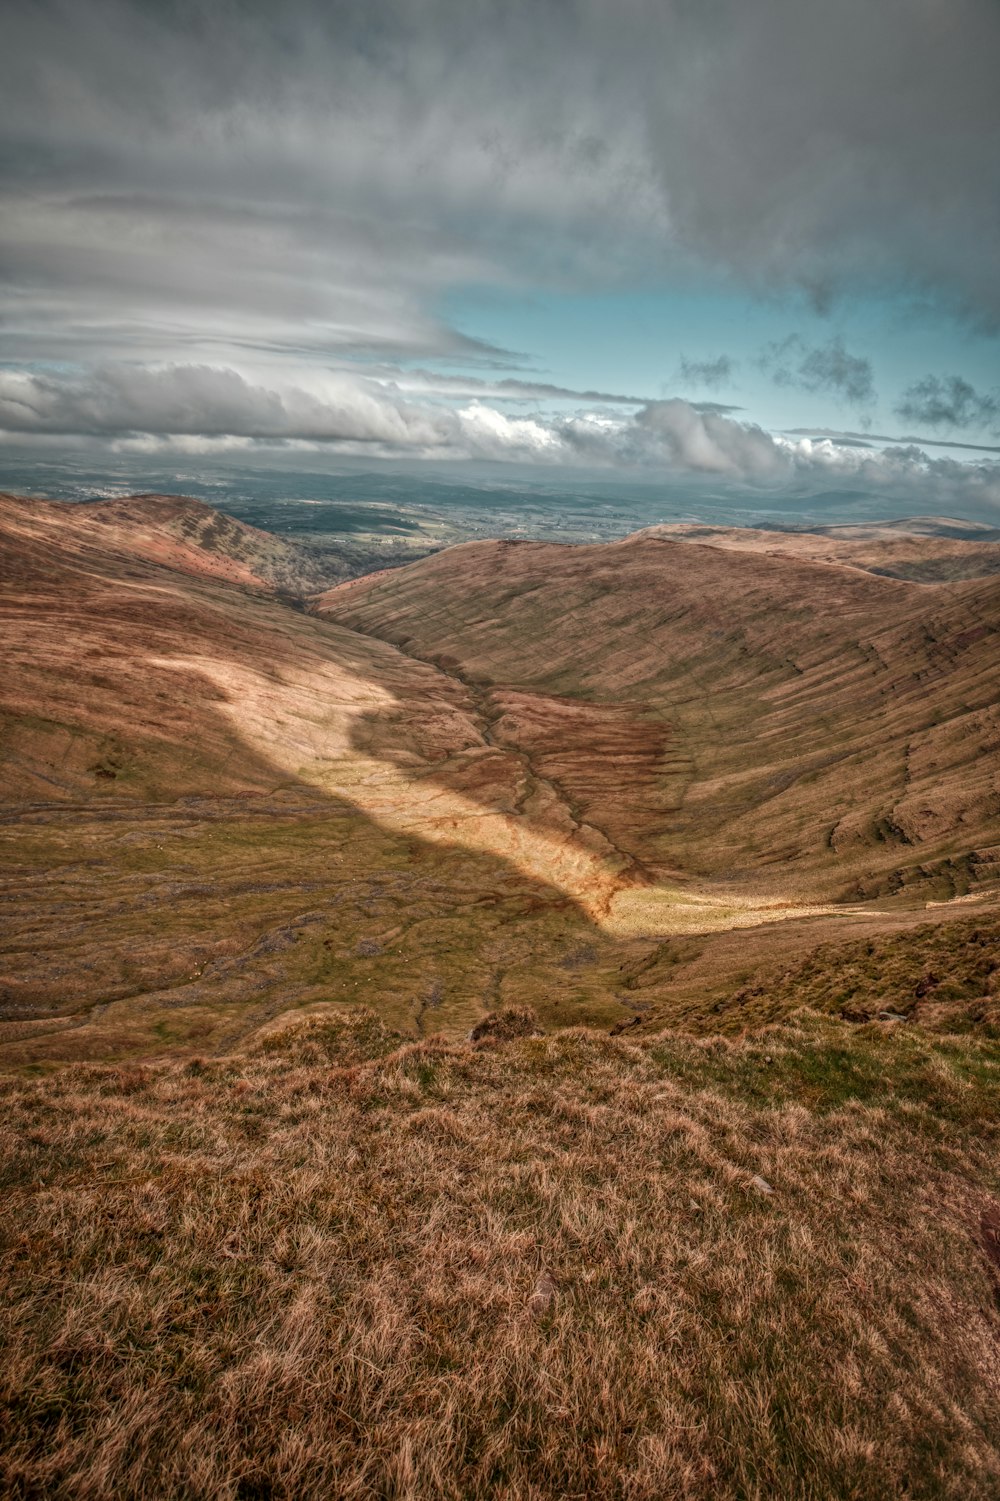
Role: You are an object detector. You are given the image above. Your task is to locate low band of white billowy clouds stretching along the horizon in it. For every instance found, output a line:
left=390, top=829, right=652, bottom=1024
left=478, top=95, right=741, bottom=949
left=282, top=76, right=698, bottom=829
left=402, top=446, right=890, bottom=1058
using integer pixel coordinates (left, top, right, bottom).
left=0, top=365, right=1000, bottom=515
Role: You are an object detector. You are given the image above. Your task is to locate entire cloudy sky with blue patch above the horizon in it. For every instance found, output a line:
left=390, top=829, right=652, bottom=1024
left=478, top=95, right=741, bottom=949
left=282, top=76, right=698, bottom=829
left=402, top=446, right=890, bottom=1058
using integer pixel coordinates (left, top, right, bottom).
left=0, top=0, right=1000, bottom=524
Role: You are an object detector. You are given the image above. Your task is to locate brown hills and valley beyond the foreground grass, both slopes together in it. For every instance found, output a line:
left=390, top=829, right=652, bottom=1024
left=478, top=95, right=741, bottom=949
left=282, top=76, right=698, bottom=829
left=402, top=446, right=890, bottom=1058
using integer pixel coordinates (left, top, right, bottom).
left=0, top=497, right=1000, bottom=1063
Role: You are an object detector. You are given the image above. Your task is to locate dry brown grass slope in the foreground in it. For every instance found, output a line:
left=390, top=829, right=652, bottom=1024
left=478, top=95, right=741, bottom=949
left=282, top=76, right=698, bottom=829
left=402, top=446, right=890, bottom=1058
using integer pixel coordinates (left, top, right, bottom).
left=0, top=1015, right=1000, bottom=1501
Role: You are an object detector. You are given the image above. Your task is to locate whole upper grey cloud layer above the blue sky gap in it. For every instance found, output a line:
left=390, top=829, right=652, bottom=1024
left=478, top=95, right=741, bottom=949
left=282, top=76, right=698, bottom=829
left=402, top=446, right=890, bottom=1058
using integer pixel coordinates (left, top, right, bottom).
left=0, top=0, right=1000, bottom=399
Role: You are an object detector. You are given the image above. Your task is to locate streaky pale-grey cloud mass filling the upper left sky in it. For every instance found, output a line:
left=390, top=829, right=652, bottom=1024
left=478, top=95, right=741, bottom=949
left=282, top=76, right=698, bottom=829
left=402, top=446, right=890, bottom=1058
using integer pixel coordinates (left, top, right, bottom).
left=0, top=0, right=665, bottom=372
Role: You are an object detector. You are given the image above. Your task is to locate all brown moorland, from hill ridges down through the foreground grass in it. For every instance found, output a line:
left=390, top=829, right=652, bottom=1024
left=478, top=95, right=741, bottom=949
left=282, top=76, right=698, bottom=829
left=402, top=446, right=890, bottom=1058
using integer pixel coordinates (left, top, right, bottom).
left=0, top=497, right=1000, bottom=1501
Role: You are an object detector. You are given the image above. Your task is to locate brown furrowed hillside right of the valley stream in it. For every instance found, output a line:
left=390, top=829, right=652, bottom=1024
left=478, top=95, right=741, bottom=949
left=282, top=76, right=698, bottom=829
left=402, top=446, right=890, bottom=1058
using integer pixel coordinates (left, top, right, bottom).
left=318, top=533, right=1000, bottom=901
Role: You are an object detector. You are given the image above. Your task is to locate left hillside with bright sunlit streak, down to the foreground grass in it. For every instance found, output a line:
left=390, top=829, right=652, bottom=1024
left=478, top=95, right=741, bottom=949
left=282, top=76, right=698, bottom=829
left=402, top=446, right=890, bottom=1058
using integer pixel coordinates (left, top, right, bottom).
left=0, top=506, right=645, bottom=1063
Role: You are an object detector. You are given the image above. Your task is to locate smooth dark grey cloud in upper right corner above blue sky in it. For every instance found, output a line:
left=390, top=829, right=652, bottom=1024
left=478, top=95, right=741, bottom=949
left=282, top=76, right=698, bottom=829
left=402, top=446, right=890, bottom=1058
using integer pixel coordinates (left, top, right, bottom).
left=638, top=0, right=1000, bottom=327
